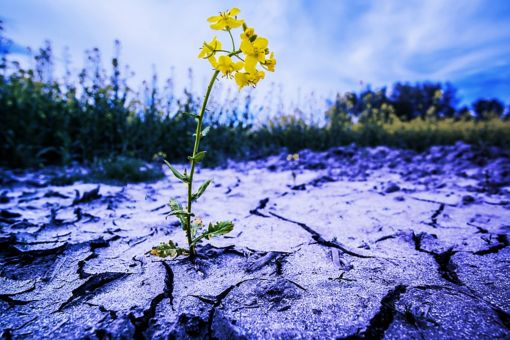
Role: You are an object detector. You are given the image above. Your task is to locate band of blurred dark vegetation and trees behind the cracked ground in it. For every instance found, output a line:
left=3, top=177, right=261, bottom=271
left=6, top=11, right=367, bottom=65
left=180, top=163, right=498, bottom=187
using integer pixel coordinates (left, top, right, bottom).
left=0, top=29, right=510, bottom=170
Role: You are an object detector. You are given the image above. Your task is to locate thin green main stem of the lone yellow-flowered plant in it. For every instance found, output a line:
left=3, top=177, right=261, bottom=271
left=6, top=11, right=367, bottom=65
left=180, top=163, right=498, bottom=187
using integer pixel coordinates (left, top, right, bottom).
left=186, top=70, right=220, bottom=257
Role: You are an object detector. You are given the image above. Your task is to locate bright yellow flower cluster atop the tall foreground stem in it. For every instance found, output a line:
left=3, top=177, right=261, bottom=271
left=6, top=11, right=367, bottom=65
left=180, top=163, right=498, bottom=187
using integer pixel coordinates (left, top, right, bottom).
left=198, top=8, right=276, bottom=89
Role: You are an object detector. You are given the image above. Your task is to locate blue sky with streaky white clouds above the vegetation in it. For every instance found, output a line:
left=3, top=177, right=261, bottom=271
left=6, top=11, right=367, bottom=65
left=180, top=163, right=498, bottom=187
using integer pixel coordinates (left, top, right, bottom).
left=0, top=0, right=510, bottom=103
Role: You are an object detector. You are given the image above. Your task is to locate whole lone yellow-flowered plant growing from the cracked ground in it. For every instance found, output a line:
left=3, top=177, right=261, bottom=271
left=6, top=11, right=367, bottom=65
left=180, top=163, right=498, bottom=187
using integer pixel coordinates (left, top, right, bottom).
left=151, top=8, right=276, bottom=257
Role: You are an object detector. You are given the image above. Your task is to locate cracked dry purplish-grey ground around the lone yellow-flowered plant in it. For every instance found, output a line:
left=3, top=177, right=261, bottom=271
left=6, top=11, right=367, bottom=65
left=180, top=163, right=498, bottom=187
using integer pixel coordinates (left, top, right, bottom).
left=0, top=143, right=510, bottom=339
